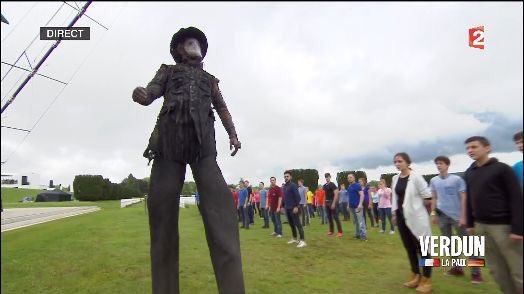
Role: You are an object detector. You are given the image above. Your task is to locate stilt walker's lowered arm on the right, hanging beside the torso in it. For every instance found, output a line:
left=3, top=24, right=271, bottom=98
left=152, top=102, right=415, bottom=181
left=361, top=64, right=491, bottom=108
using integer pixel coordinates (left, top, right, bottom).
left=211, top=79, right=241, bottom=156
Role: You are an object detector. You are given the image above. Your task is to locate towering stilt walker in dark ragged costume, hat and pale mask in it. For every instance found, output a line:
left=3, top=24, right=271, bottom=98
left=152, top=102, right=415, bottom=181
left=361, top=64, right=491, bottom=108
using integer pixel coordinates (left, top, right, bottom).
left=132, top=27, right=245, bottom=294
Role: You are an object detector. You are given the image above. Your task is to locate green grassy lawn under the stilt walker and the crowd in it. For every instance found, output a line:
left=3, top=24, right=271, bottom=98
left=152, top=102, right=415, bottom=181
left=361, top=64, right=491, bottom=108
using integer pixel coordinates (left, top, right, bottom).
left=1, top=201, right=498, bottom=294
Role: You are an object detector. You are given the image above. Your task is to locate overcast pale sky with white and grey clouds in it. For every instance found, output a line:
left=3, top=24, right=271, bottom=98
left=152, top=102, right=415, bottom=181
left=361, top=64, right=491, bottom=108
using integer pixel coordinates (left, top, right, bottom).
left=1, top=2, right=523, bottom=185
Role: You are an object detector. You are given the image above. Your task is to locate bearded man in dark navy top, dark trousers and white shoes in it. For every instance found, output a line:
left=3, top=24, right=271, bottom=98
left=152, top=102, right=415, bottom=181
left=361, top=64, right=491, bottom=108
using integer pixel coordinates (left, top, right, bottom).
left=282, top=171, right=306, bottom=248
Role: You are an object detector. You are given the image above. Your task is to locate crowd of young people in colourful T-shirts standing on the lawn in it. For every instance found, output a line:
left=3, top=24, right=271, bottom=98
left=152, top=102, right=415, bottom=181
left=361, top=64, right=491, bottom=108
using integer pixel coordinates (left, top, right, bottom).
left=227, top=131, right=523, bottom=293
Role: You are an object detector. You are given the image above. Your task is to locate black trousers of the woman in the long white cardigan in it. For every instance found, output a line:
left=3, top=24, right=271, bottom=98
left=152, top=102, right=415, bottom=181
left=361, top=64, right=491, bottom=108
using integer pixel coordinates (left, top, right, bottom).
left=396, top=209, right=431, bottom=278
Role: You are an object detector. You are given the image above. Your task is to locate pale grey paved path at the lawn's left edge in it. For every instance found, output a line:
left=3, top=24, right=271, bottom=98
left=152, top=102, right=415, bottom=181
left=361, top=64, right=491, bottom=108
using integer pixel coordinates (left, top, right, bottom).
left=2, top=206, right=100, bottom=232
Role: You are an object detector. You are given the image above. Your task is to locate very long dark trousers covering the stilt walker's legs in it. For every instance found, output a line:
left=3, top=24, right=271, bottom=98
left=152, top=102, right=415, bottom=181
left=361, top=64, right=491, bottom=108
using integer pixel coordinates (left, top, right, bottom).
left=147, top=156, right=245, bottom=294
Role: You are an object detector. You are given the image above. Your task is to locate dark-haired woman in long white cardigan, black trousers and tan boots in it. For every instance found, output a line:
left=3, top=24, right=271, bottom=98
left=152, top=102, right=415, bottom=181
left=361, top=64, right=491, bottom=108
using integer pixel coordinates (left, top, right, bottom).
left=391, top=152, right=432, bottom=293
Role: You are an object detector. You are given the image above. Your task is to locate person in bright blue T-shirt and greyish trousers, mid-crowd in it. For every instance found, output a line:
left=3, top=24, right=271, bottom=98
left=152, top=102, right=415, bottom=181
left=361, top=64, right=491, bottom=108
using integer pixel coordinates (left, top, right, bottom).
left=348, top=174, right=367, bottom=241
